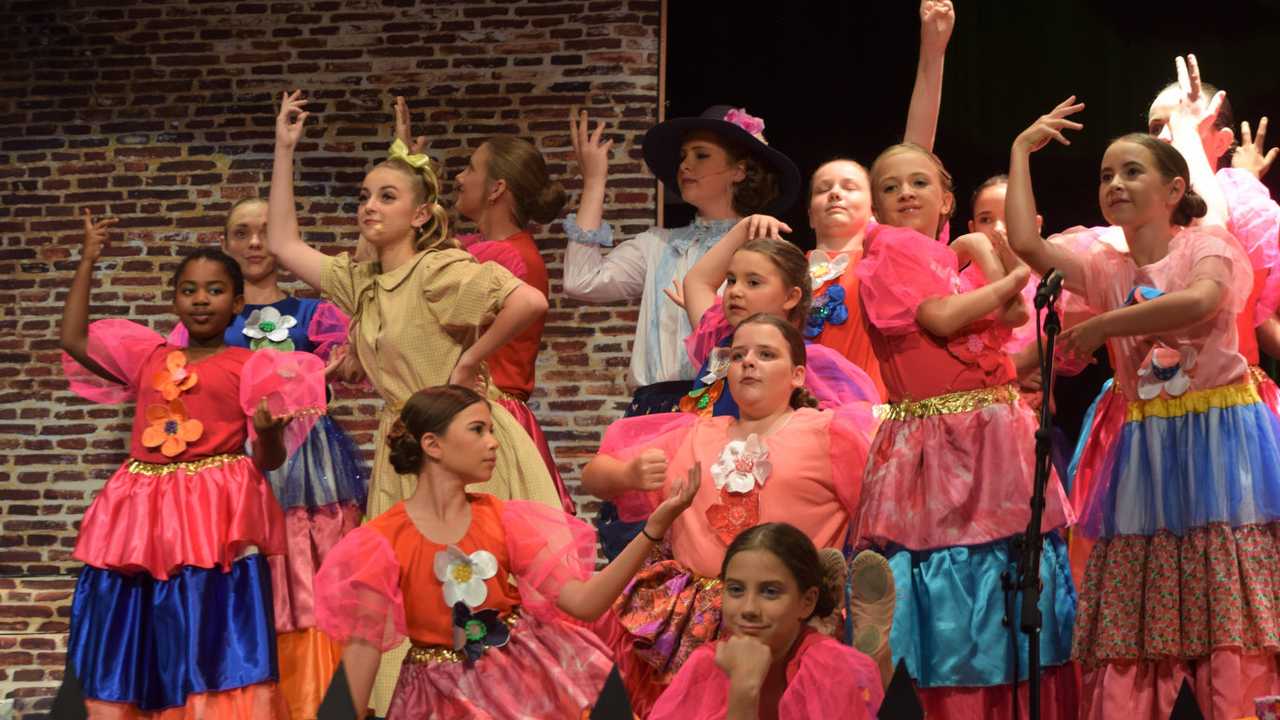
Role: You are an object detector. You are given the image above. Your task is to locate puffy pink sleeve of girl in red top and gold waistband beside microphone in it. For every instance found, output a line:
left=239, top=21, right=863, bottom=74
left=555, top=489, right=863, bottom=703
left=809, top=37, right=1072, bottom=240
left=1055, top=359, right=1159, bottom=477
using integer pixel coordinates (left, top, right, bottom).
left=854, top=225, right=961, bottom=334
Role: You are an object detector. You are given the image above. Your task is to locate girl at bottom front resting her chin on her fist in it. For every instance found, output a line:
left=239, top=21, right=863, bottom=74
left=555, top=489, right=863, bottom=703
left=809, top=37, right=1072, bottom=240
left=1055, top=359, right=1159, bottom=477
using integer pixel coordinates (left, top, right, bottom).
left=649, top=523, right=884, bottom=720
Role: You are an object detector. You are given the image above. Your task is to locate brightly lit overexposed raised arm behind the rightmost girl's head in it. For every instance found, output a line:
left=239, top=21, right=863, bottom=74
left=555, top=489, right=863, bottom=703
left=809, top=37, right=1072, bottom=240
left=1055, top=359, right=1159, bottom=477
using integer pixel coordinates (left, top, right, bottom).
left=1169, top=55, right=1228, bottom=228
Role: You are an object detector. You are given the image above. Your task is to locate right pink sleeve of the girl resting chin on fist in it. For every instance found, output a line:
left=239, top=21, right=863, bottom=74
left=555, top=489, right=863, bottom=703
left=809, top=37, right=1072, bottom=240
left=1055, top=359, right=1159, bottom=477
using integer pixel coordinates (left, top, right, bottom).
left=778, top=639, right=884, bottom=720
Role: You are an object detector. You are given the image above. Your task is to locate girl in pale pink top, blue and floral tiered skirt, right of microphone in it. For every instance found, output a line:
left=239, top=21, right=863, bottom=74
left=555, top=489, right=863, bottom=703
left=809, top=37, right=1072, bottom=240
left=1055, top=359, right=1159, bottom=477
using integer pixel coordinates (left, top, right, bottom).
left=1007, top=90, right=1280, bottom=719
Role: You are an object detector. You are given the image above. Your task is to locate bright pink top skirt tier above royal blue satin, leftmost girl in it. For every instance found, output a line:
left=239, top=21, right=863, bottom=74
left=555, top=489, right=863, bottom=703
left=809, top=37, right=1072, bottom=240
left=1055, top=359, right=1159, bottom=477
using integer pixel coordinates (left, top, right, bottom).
left=74, top=456, right=285, bottom=580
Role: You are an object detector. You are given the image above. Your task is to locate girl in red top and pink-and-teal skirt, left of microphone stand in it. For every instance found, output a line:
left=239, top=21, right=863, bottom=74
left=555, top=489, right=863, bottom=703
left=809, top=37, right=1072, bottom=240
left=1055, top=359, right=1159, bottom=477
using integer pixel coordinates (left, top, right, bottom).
left=855, top=145, right=1075, bottom=717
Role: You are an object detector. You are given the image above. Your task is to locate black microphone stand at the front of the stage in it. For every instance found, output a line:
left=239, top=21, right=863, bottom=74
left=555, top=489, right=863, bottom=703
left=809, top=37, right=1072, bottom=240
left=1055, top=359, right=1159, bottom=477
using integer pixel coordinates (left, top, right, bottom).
left=1014, top=270, right=1062, bottom=720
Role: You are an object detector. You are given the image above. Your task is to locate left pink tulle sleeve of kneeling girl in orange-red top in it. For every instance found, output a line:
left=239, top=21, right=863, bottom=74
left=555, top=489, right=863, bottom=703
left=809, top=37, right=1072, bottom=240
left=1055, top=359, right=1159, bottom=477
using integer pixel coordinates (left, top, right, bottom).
left=314, top=525, right=408, bottom=652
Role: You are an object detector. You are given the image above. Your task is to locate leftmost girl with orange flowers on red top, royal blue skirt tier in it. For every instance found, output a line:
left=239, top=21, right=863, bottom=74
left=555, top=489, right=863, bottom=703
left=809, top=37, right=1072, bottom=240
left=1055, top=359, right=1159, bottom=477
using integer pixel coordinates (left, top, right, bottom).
left=61, top=213, right=325, bottom=720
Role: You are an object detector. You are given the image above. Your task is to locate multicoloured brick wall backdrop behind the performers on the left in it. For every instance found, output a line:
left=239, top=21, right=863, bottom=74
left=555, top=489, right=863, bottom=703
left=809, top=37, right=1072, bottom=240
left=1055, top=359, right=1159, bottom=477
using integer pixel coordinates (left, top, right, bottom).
left=0, top=0, right=658, bottom=717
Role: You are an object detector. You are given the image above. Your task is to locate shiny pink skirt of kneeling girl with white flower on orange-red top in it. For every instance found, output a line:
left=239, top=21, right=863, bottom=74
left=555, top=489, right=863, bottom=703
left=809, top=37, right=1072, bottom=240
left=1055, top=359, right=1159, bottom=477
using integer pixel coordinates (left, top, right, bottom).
left=387, top=615, right=612, bottom=720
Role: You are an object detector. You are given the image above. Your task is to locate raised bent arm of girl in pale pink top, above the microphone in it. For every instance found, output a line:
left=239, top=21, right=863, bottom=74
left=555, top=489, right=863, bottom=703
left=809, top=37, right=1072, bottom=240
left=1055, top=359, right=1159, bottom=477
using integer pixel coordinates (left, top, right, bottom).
left=1005, top=95, right=1084, bottom=288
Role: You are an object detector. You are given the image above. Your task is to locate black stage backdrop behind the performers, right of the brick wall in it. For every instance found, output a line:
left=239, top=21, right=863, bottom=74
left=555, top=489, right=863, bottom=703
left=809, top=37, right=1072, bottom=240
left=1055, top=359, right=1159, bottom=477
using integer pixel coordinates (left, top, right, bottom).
left=666, top=0, right=1280, bottom=439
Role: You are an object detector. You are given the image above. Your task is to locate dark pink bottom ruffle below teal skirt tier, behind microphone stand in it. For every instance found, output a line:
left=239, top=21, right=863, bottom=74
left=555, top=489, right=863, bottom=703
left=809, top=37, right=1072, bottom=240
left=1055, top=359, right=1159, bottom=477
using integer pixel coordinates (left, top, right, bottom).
left=915, top=664, right=1080, bottom=720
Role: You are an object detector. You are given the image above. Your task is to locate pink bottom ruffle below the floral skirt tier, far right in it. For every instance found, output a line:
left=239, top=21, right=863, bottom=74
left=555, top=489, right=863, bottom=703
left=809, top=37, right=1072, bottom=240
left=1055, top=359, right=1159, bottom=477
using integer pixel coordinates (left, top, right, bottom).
left=1080, top=648, right=1280, bottom=720
